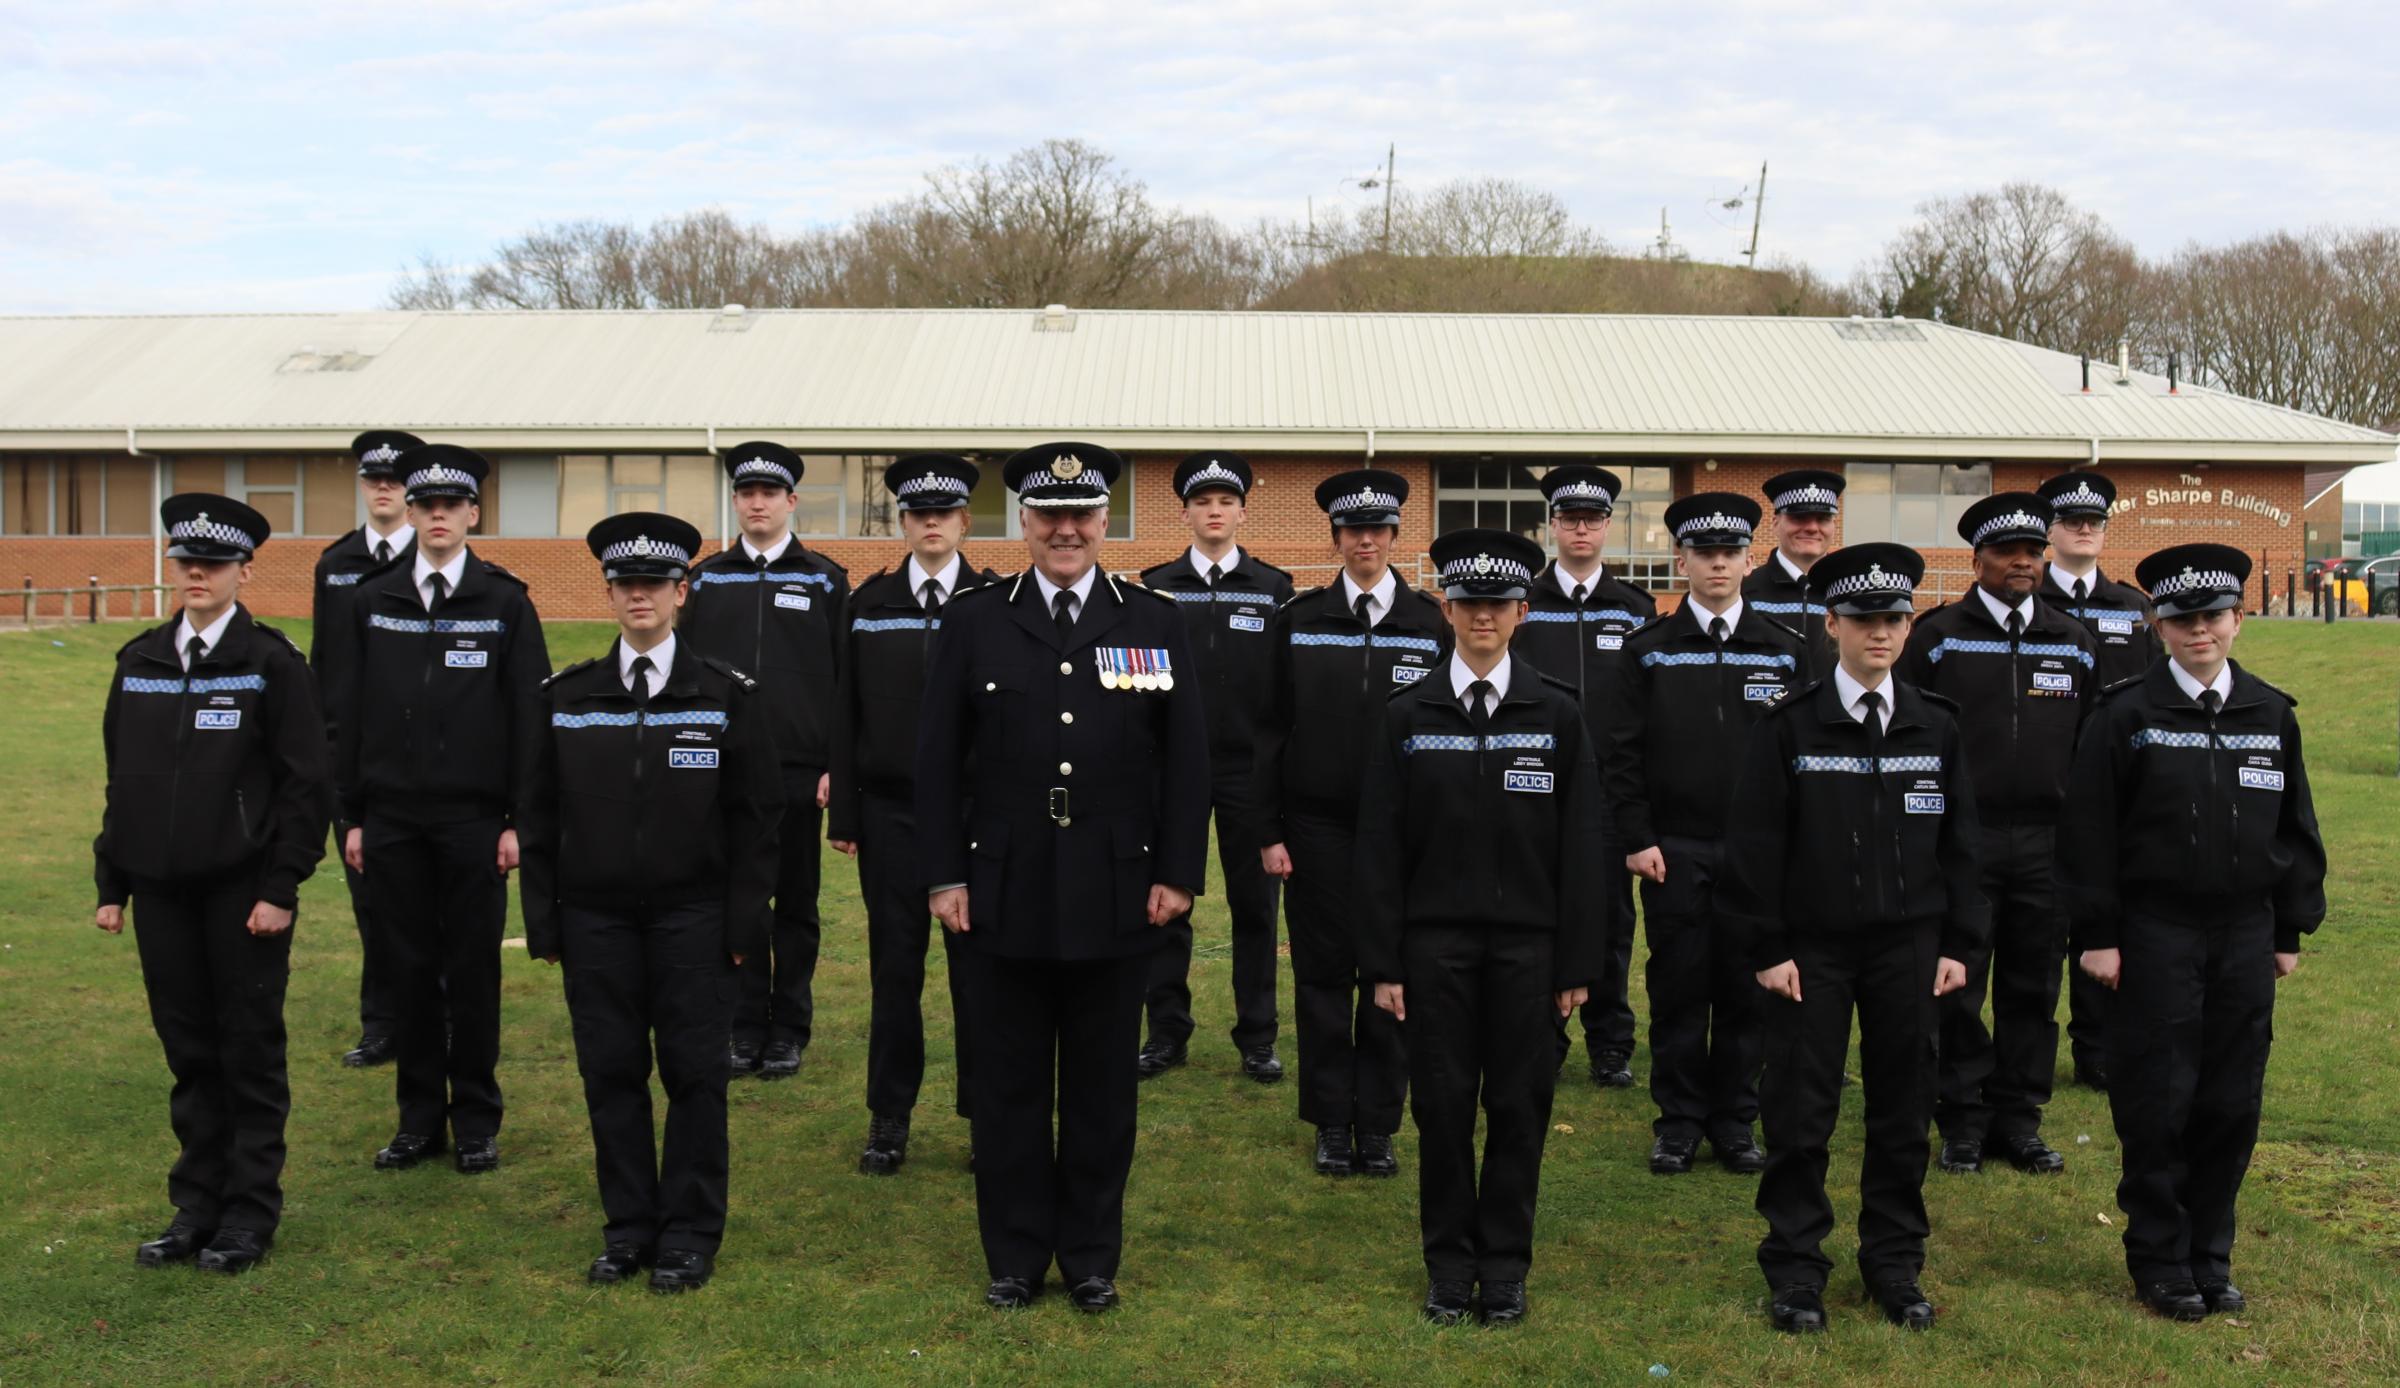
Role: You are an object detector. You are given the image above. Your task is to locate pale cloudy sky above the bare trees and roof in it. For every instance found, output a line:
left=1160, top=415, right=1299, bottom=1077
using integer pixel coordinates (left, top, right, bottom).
left=0, top=0, right=2400, bottom=315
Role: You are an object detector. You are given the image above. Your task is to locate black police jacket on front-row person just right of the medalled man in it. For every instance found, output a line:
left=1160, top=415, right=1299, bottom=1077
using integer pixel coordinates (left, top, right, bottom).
left=1356, top=656, right=1620, bottom=992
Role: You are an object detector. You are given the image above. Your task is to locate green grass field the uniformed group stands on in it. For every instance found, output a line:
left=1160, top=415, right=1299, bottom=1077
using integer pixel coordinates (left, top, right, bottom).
left=0, top=622, right=2400, bottom=1388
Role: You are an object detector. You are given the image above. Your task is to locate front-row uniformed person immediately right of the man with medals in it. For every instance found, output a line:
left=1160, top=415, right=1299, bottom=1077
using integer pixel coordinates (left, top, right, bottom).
left=1358, top=531, right=1618, bottom=1326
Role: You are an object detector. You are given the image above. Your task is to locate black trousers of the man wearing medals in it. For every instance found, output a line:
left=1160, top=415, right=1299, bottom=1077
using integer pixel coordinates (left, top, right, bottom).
left=955, top=944, right=1150, bottom=1285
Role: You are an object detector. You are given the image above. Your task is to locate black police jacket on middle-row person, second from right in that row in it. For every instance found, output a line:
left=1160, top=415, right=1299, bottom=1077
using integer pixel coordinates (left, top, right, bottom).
left=1594, top=598, right=1802, bottom=852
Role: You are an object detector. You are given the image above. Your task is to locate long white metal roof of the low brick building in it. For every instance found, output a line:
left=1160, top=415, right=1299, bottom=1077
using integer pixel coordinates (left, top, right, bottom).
left=0, top=310, right=2395, bottom=463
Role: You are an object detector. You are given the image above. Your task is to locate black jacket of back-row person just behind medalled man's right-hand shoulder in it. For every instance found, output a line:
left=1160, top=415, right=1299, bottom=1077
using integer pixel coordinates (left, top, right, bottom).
left=1142, top=550, right=1291, bottom=771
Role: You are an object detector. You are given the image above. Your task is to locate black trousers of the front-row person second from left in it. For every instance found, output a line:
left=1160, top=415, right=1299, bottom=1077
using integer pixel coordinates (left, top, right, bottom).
left=559, top=903, right=734, bottom=1256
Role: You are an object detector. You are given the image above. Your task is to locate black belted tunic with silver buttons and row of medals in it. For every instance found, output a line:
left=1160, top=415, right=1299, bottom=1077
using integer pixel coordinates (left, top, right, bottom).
left=917, top=574, right=1210, bottom=958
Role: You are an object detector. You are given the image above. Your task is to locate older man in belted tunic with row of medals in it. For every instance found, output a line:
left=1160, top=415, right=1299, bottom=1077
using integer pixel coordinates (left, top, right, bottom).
left=917, top=444, right=1210, bottom=1314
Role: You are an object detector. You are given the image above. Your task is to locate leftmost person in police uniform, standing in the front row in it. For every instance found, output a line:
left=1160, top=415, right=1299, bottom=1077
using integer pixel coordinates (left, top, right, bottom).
left=91, top=492, right=331, bottom=1273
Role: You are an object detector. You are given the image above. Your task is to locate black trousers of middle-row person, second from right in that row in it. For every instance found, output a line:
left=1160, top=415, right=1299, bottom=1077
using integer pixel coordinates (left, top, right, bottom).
left=1642, top=838, right=1766, bottom=1143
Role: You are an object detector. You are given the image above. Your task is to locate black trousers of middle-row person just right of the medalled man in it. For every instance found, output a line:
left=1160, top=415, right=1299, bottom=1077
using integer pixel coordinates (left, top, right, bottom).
left=1284, top=812, right=1409, bottom=1133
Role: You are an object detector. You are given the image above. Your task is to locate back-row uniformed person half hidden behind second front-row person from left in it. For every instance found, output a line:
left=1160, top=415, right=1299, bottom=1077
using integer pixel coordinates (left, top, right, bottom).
left=682, top=442, right=850, bottom=1081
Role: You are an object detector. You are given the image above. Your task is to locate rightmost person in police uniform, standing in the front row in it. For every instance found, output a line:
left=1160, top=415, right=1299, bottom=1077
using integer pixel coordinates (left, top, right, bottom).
left=2059, top=545, right=2326, bottom=1321
